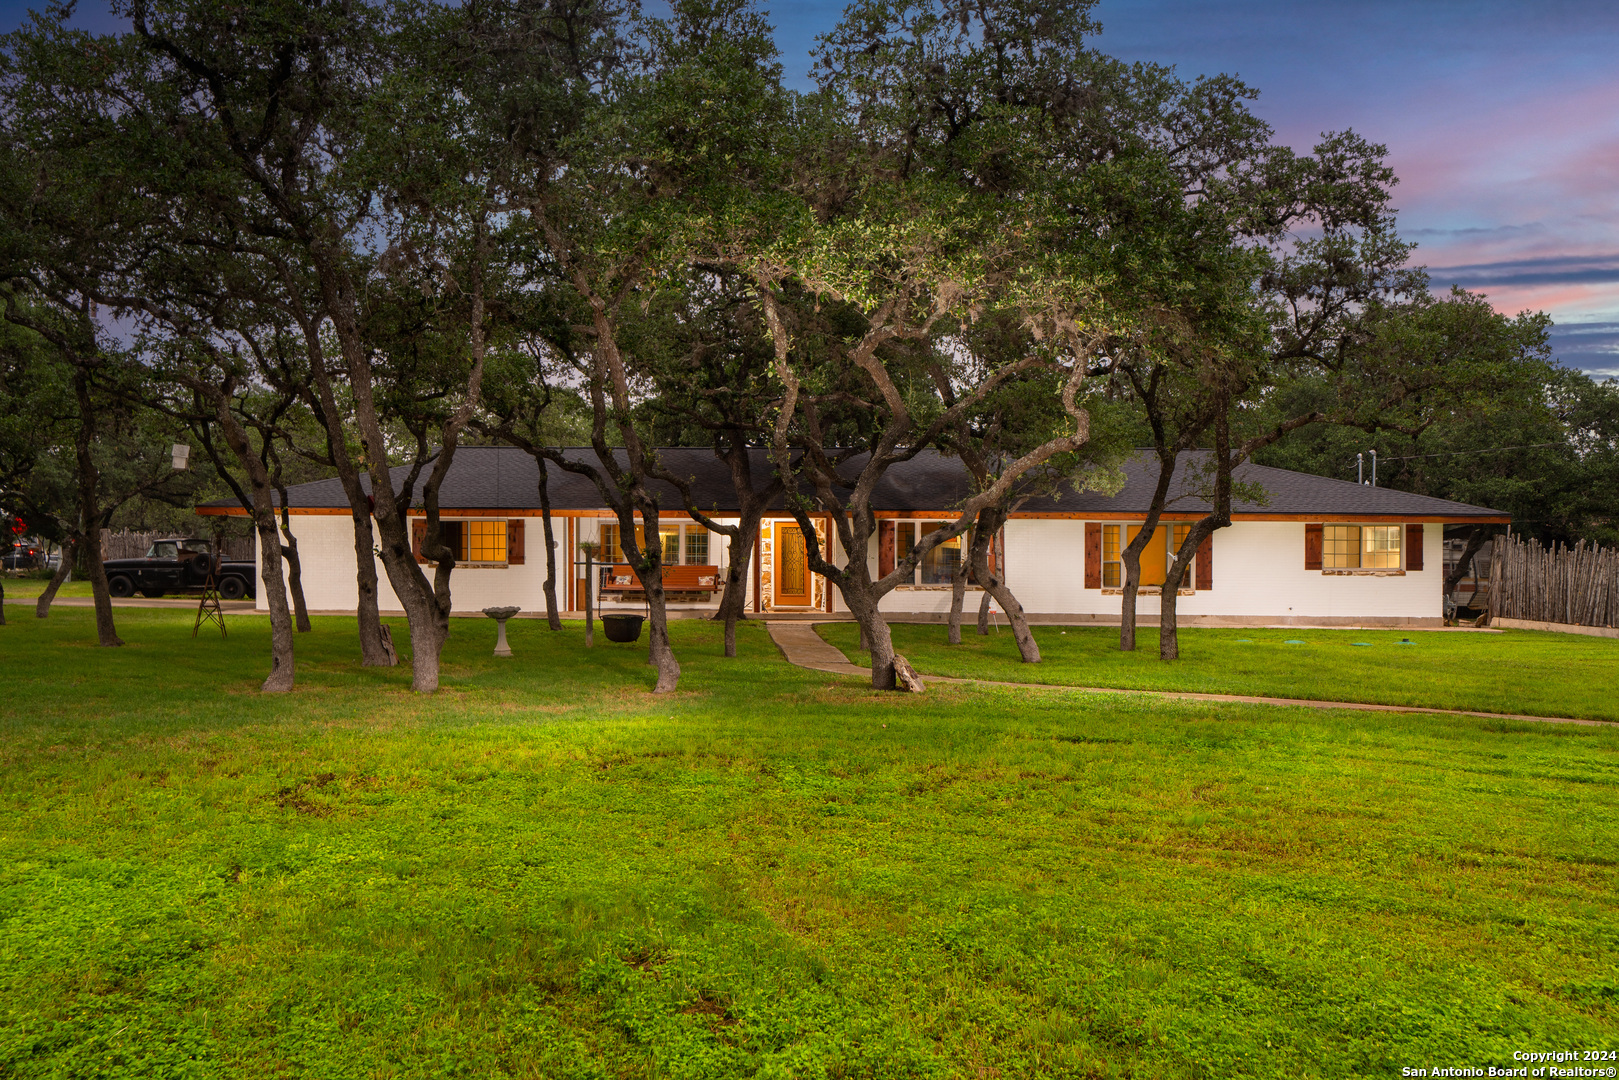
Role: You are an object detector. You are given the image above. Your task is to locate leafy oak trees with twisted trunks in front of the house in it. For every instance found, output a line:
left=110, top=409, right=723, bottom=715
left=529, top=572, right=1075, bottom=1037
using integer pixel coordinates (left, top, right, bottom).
left=0, top=0, right=1619, bottom=690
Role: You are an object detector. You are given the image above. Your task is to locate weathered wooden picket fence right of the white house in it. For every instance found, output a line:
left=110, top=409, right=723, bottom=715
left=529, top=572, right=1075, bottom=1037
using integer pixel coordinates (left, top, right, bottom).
left=1489, top=536, right=1619, bottom=627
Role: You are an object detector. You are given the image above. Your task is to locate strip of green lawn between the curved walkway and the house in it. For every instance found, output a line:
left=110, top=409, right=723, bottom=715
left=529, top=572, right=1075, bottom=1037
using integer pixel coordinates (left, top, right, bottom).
left=816, top=620, right=1619, bottom=721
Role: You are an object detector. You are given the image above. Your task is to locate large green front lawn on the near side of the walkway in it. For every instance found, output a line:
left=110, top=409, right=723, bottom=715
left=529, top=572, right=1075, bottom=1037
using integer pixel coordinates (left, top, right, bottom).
left=0, top=609, right=1619, bottom=1078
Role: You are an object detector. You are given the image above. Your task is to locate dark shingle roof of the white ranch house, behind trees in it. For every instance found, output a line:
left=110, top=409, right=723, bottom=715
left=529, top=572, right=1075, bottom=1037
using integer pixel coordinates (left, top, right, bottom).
left=209, top=447, right=1506, bottom=521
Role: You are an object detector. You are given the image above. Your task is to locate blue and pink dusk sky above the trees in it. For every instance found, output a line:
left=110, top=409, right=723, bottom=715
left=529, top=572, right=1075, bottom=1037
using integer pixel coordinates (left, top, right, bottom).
left=0, top=0, right=1619, bottom=376
